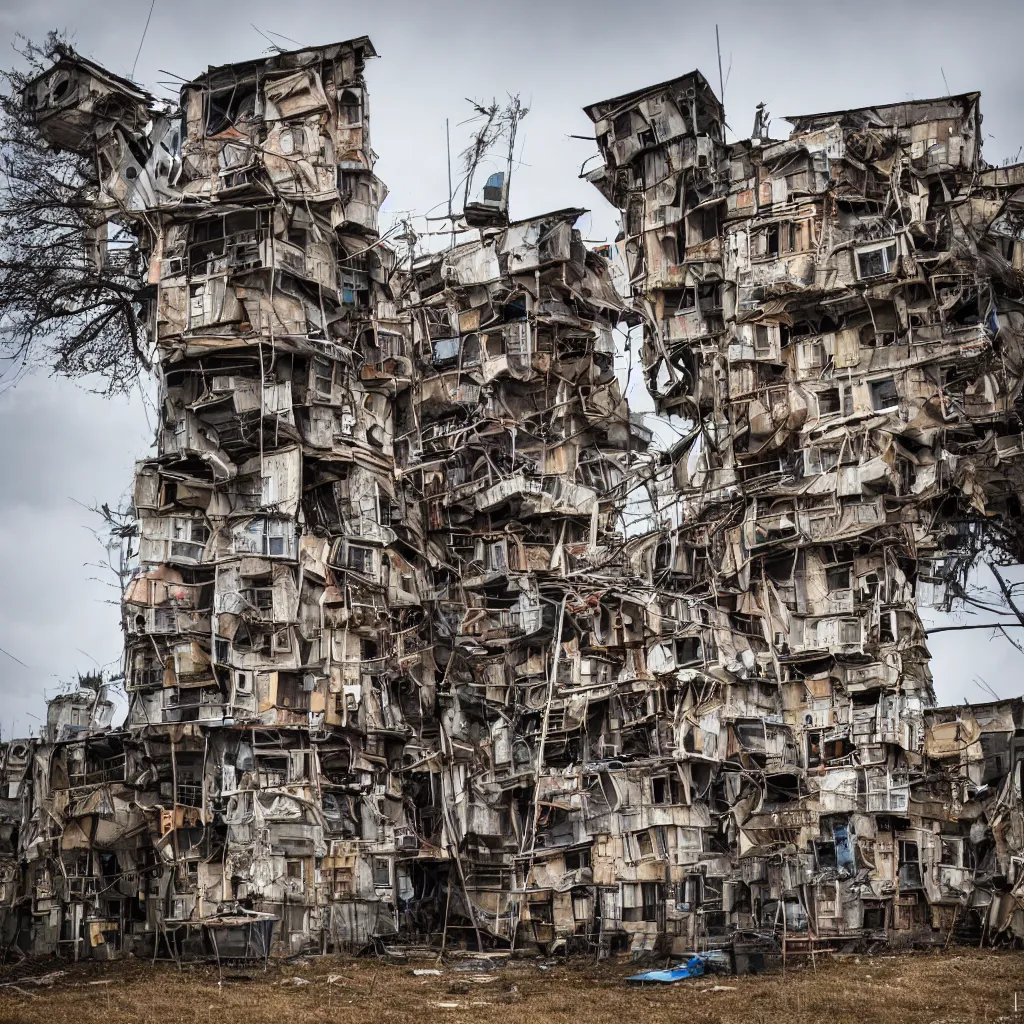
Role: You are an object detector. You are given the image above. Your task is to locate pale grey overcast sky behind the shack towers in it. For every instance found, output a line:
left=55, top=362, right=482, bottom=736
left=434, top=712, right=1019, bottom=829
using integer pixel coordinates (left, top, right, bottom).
left=0, top=0, right=1024, bottom=737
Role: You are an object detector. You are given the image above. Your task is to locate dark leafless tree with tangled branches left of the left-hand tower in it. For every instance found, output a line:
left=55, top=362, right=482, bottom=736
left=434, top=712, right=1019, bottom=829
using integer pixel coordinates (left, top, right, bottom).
left=0, top=35, right=150, bottom=393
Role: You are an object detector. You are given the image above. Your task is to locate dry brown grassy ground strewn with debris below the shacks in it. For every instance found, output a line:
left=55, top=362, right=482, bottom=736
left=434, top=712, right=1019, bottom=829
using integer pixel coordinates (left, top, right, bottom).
left=0, top=949, right=1024, bottom=1024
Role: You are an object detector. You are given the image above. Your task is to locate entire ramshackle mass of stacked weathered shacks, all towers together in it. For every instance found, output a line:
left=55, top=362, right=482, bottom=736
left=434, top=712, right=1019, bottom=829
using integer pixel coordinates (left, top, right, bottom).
left=0, top=38, right=1024, bottom=966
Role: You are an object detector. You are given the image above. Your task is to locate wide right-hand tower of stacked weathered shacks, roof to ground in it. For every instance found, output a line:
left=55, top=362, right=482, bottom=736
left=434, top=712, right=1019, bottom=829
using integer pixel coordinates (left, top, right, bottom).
left=587, top=72, right=1024, bottom=939
